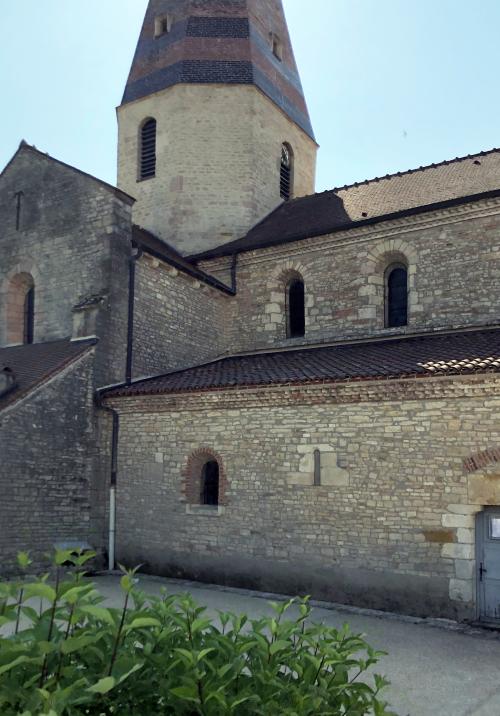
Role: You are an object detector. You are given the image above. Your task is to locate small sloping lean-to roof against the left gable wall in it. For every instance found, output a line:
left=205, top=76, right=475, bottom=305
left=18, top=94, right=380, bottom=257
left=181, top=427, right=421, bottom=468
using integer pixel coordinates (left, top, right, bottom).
left=0, top=338, right=96, bottom=410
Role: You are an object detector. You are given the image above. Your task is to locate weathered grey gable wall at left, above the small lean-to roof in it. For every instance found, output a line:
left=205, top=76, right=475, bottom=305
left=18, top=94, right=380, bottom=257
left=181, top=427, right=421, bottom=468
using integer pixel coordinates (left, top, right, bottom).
left=0, top=147, right=131, bottom=384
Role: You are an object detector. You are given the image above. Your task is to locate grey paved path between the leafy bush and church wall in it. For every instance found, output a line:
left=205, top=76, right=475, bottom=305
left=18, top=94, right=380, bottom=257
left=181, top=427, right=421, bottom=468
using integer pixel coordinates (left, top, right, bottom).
left=96, top=575, right=500, bottom=716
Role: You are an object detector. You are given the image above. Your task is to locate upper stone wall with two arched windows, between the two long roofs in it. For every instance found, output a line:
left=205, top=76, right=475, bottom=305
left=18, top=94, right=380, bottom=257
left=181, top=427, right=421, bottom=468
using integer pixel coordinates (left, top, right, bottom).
left=200, top=199, right=500, bottom=351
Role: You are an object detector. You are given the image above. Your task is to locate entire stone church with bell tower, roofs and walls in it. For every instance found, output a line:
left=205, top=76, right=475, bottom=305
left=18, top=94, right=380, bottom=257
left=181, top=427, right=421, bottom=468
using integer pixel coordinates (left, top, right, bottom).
left=0, top=0, right=500, bottom=622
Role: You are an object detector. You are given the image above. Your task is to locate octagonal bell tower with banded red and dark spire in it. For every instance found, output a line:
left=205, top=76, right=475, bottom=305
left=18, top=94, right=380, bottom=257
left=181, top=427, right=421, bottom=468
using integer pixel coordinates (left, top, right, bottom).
left=118, top=0, right=317, bottom=254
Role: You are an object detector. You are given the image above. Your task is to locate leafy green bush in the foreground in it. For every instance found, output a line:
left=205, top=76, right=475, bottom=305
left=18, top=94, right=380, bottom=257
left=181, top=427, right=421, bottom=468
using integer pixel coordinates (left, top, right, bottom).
left=0, top=551, right=389, bottom=716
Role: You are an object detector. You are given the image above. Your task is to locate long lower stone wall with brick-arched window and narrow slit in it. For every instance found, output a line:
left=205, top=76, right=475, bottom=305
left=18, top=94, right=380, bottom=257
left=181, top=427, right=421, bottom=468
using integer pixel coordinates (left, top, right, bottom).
left=110, top=376, right=500, bottom=618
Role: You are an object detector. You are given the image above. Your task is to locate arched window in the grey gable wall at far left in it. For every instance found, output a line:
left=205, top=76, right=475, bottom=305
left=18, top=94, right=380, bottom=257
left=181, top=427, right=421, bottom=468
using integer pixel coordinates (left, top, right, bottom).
left=6, top=273, right=35, bottom=344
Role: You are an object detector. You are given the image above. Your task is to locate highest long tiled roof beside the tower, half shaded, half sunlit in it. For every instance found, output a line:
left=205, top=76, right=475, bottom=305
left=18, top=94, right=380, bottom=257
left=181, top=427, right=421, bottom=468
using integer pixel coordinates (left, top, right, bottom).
left=192, top=149, right=500, bottom=260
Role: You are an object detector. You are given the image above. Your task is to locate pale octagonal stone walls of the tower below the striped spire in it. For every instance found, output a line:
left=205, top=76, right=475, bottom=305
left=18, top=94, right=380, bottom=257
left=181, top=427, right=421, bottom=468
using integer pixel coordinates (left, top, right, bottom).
left=118, top=84, right=316, bottom=254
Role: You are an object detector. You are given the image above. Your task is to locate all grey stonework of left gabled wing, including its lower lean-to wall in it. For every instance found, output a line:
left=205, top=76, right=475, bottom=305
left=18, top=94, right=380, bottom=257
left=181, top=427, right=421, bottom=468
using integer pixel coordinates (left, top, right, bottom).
left=0, top=146, right=132, bottom=570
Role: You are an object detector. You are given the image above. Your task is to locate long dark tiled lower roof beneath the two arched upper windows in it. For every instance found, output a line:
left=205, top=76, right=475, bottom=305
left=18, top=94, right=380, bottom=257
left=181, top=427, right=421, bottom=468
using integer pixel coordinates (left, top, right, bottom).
left=101, top=328, right=500, bottom=396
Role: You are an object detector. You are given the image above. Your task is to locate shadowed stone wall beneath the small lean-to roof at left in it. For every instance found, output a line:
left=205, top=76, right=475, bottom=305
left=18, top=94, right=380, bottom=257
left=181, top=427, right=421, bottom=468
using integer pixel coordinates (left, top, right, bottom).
left=0, top=349, right=103, bottom=574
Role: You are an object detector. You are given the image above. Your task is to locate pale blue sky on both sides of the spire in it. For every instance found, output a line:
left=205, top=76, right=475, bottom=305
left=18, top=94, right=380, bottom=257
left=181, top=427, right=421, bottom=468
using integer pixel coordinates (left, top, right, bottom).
left=0, top=0, right=500, bottom=191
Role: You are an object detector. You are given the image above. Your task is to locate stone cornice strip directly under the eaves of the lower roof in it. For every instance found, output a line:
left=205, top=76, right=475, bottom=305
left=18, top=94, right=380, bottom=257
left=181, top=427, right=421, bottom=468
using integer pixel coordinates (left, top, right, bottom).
left=104, top=373, right=500, bottom=413
